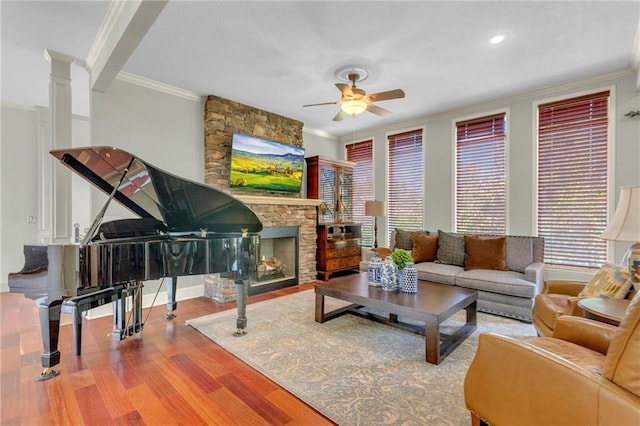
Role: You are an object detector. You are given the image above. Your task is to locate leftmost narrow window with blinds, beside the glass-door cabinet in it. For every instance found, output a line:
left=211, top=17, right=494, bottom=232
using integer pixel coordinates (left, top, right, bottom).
left=345, top=140, right=373, bottom=246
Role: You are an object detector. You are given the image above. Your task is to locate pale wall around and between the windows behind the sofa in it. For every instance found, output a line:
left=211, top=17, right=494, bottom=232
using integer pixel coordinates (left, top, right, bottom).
left=340, top=71, right=640, bottom=279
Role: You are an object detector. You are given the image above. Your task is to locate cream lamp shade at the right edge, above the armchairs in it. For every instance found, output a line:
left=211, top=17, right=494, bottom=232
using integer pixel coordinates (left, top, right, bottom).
left=600, top=186, right=640, bottom=241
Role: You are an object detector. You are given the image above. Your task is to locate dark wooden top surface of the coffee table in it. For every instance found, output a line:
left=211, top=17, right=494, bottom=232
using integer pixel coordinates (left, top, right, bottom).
left=315, top=272, right=478, bottom=325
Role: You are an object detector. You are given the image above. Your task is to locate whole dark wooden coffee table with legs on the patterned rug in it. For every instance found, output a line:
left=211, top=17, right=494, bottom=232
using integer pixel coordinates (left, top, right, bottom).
left=315, top=272, right=478, bottom=364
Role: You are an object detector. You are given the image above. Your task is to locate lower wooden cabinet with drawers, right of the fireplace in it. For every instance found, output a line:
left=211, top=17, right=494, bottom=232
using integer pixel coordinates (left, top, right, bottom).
left=316, top=223, right=362, bottom=281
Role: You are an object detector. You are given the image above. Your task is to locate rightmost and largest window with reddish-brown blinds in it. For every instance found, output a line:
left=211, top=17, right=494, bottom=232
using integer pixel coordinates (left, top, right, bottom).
left=537, top=91, right=609, bottom=267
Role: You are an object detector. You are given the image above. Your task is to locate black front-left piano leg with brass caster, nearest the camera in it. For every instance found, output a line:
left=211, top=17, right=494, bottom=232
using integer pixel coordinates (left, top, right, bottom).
left=35, top=300, right=62, bottom=382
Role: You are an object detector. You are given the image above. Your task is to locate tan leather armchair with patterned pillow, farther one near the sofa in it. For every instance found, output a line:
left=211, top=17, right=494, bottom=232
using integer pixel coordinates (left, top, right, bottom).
left=532, top=280, right=587, bottom=336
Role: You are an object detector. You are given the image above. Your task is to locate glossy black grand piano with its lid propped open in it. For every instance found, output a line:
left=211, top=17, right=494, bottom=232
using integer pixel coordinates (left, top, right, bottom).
left=8, top=147, right=262, bottom=381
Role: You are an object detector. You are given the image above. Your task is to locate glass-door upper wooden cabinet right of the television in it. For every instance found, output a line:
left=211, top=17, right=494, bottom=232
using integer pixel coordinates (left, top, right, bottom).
left=305, top=156, right=356, bottom=223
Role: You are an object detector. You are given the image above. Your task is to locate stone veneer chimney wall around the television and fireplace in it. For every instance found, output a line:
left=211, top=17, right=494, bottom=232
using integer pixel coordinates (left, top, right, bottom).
left=204, top=95, right=317, bottom=284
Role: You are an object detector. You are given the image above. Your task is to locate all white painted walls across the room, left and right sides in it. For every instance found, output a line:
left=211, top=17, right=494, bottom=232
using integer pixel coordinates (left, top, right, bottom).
left=0, top=72, right=640, bottom=291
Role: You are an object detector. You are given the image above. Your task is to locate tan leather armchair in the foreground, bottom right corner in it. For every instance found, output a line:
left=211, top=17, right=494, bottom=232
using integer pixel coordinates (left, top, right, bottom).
left=464, top=294, right=640, bottom=426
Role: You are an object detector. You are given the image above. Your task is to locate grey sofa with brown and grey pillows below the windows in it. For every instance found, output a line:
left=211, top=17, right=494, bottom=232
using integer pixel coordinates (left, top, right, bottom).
left=360, top=229, right=544, bottom=323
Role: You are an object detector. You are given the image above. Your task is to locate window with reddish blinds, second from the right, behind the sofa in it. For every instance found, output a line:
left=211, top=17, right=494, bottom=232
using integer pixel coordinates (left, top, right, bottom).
left=456, top=113, right=507, bottom=234
